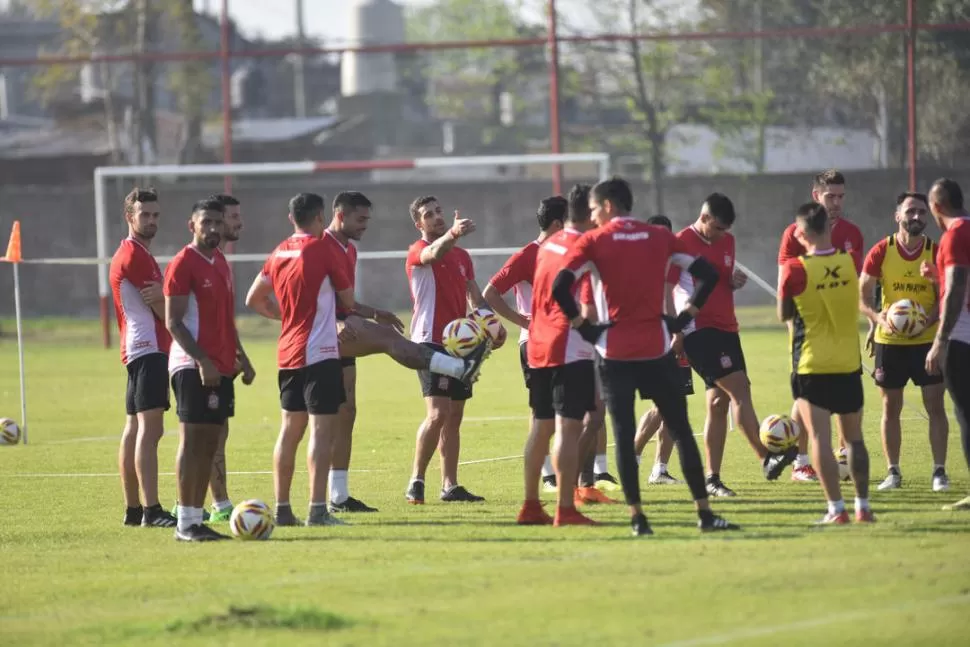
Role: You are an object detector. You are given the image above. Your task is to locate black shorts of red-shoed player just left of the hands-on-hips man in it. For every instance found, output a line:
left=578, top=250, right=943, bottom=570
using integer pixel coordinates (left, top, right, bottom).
left=529, top=360, right=596, bottom=420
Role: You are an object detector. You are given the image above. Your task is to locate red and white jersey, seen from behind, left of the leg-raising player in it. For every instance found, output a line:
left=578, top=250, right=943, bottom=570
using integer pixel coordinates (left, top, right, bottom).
left=261, top=234, right=353, bottom=370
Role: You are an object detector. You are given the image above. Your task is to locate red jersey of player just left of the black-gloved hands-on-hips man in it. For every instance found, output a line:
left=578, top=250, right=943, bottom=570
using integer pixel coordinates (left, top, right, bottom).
left=528, top=228, right=593, bottom=368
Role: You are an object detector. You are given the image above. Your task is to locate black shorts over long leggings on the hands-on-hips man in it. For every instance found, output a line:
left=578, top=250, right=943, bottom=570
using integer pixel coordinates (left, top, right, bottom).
left=597, top=353, right=686, bottom=403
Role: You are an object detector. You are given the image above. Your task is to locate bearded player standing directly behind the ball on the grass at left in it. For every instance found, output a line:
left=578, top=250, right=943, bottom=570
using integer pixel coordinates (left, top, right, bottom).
left=164, top=199, right=249, bottom=541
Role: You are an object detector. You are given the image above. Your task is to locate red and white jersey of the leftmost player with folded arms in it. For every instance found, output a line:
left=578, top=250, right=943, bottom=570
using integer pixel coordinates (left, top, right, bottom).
left=108, top=236, right=172, bottom=365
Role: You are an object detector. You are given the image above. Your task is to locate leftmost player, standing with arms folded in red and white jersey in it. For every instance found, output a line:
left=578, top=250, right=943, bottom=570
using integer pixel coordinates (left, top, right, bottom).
left=109, top=187, right=175, bottom=528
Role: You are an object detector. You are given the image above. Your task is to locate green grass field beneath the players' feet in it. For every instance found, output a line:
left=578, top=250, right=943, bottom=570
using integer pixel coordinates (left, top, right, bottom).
left=0, top=311, right=970, bottom=645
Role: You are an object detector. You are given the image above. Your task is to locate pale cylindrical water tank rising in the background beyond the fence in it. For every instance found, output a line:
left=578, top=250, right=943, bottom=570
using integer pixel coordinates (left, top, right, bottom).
left=340, top=0, right=404, bottom=97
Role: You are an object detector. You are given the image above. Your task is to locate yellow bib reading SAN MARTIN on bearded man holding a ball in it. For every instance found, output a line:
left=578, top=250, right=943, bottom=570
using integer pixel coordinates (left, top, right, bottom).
left=875, top=235, right=936, bottom=346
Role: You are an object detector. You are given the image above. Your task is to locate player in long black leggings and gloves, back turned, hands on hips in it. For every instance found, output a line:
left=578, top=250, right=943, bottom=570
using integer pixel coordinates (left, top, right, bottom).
left=553, top=178, right=738, bottom=535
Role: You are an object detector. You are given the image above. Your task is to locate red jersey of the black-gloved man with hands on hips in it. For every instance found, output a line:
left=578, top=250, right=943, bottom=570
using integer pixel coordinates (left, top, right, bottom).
left=566, top=216, right=694, bottom=360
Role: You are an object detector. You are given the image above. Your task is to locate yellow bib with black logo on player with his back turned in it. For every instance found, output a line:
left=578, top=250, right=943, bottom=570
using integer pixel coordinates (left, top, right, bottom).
left=791, top=250, right=862, bottom=375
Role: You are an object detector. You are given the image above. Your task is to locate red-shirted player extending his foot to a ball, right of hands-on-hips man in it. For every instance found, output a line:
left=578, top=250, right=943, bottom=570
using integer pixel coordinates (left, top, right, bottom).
left=674, top=193, right=797, bottom=496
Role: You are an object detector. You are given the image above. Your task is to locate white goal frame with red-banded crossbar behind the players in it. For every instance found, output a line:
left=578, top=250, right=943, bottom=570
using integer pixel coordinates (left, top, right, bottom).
left=89, top=153, right=610, bottom=348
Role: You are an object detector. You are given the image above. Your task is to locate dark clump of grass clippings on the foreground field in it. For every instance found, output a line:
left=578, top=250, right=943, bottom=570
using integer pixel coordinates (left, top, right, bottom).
left=167, top=605, right=353, bottom=633
